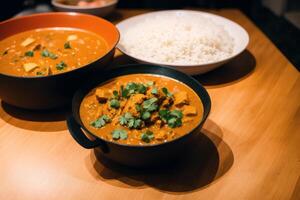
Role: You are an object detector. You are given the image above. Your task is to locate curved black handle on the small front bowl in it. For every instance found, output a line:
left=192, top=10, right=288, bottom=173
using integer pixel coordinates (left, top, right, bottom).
left=67, top=116, right=108, bottom=153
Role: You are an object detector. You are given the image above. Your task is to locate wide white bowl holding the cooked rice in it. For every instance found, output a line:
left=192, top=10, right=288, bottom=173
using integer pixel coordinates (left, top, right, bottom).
left=116, top=10, right=249, bottom=75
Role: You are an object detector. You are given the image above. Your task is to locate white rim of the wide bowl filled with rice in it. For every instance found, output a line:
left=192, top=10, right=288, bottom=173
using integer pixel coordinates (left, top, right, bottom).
left=116, top=9, right=250, bottom=67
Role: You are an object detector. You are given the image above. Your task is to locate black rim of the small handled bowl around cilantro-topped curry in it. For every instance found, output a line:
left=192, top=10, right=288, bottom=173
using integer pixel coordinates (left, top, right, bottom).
left=71, top=64, right=212, bottom=148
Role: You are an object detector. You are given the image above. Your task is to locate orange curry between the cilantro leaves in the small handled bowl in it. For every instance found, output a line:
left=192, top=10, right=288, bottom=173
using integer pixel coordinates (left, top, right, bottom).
left=80, top=74, right=203, bottom=145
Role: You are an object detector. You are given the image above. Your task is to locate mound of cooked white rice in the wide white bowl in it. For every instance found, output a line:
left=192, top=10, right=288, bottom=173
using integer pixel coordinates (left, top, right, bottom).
left=120, top=16, right=234, bottom=65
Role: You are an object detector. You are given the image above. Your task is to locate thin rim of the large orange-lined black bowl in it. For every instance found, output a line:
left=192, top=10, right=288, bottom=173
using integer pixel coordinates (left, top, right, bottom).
left=0, top=12, right=120, bottom=79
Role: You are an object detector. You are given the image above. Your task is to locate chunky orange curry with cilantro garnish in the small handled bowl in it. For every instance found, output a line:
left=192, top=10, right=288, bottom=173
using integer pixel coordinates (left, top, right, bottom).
left=80, top=74, right=203, bottom=145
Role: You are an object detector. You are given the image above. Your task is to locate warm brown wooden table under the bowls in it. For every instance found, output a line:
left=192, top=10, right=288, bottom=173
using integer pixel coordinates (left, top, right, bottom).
left=0, top=10, right=300, bottom=200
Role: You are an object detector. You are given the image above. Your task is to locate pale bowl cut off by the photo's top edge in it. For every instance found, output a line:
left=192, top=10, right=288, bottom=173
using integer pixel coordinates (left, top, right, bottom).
left=51, top=0, right=118, bottom=17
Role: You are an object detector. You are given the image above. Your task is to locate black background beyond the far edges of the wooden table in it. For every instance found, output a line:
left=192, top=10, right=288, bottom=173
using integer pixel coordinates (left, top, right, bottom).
left=0, top=0, right=300, bottom=70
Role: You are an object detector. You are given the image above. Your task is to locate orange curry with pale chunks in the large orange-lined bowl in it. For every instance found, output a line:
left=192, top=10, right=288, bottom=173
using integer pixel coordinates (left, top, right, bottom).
left=0, top=28, right=108, bottom=76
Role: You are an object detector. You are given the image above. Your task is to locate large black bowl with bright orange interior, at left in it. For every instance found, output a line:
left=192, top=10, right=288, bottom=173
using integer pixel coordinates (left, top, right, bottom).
left=0, top=12, right=119, bottom=109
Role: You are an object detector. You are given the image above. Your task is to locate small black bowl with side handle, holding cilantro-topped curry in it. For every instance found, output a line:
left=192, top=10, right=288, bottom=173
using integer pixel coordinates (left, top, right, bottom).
left=67, top=64, right=211, bottom=167
